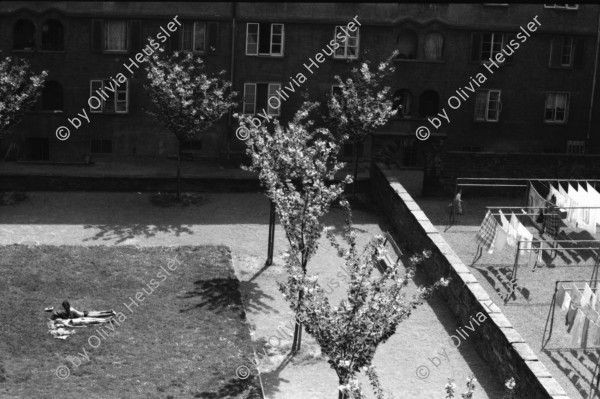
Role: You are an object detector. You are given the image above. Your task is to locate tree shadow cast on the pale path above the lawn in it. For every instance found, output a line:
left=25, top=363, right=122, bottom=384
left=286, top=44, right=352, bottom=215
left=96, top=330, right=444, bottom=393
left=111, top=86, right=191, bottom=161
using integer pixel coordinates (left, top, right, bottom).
left=83, top=224, right=194, bottom=244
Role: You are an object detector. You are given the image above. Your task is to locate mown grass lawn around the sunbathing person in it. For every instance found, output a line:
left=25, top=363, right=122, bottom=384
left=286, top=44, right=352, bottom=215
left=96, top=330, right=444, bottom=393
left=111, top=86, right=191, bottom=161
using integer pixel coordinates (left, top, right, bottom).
left=0, top=245, right=260, bottom=399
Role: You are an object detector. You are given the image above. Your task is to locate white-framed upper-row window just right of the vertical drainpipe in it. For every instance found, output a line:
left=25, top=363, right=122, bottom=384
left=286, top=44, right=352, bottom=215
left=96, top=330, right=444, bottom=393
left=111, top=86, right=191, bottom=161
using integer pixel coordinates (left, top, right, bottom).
left=246, top=23, right=285, bottom=57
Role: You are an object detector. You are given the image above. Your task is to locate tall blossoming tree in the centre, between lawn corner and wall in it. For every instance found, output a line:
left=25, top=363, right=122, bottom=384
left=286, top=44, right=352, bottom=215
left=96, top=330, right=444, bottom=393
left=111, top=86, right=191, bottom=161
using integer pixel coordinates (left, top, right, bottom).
left=238, top=101, right=351, bottom=352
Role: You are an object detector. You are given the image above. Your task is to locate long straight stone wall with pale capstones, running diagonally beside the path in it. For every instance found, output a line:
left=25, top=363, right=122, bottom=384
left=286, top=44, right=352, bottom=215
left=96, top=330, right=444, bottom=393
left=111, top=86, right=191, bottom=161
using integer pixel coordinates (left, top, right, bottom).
left=371, top=164, right=568, bottom=399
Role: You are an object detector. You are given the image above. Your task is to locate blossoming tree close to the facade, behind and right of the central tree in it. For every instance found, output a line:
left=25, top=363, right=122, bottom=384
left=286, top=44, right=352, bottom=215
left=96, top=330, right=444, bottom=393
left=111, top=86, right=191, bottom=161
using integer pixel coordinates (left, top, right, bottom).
left=324, top=51, right=398, bottom=198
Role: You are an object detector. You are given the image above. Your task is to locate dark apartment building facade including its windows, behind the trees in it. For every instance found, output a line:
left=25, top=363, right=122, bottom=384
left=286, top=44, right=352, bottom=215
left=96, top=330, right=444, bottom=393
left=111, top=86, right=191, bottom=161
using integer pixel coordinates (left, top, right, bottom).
left=0, top=1, right=600, bottom=167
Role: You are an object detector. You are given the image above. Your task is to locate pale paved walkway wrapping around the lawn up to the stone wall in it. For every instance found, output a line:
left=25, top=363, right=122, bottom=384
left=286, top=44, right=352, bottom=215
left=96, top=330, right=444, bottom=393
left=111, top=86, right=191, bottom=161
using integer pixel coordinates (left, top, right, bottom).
left=0, top=192, right=502, bottom=399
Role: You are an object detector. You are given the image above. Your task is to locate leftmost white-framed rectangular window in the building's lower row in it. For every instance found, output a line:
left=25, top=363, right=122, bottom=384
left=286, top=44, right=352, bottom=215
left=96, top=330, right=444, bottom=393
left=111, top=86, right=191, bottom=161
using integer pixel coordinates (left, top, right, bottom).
left=88, top=79, right=129, bottom=114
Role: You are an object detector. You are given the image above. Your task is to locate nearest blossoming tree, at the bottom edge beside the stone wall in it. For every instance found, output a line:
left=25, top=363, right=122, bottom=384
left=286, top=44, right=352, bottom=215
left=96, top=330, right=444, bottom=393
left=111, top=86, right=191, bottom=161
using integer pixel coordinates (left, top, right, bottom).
left=279, top=205, right=448, bottom=399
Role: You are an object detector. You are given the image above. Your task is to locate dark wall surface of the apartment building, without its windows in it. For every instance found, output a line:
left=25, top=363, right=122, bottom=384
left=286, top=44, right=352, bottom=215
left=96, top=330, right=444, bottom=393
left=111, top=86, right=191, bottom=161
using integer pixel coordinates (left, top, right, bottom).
left=0, top=2, right=600, bottom=162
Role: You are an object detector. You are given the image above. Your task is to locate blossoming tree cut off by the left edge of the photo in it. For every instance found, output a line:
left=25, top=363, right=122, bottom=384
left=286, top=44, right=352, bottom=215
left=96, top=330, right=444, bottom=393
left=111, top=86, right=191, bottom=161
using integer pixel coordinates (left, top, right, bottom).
left=0, top=57, right=48, bottom=139
